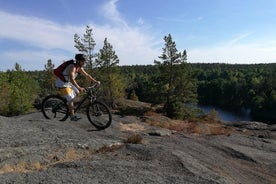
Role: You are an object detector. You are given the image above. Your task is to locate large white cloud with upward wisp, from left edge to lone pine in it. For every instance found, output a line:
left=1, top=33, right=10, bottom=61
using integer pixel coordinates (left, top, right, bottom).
left=0, top=0, right=160, bottom=71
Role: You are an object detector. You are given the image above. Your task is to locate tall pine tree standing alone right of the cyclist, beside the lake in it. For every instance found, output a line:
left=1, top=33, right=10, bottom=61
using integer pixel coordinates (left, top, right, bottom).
left=154, top=34, right=197, bottom=118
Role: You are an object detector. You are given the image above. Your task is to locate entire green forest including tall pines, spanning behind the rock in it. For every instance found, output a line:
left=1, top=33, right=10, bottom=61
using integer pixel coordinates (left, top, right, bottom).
left=0, top=26, right=276, bottom=124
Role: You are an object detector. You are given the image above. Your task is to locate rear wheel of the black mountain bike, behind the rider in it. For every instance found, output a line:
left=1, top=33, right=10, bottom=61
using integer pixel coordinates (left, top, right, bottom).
left=41, top=95, right=69, bottom=121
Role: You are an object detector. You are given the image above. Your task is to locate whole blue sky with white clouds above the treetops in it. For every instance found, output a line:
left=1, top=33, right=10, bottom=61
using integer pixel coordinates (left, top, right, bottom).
left=0, top=0, right=276, bottom=71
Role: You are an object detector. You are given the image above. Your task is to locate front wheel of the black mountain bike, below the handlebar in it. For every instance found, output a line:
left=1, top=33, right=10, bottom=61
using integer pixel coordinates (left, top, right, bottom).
left=86, top=101, right=112, bottom=130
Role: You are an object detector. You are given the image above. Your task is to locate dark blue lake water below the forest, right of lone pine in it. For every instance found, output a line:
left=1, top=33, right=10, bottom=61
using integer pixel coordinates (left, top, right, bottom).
left=198, top=105, right=252, bottom=122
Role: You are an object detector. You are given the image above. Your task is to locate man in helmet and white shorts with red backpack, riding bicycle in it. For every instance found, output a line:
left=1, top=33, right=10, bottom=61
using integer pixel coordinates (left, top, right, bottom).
left=56, top=54, right=100, bottom=121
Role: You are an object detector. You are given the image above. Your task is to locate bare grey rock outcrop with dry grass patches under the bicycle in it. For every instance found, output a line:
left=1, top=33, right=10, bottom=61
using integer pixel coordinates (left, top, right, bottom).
left=0, top=112, right=276, bottom=184
